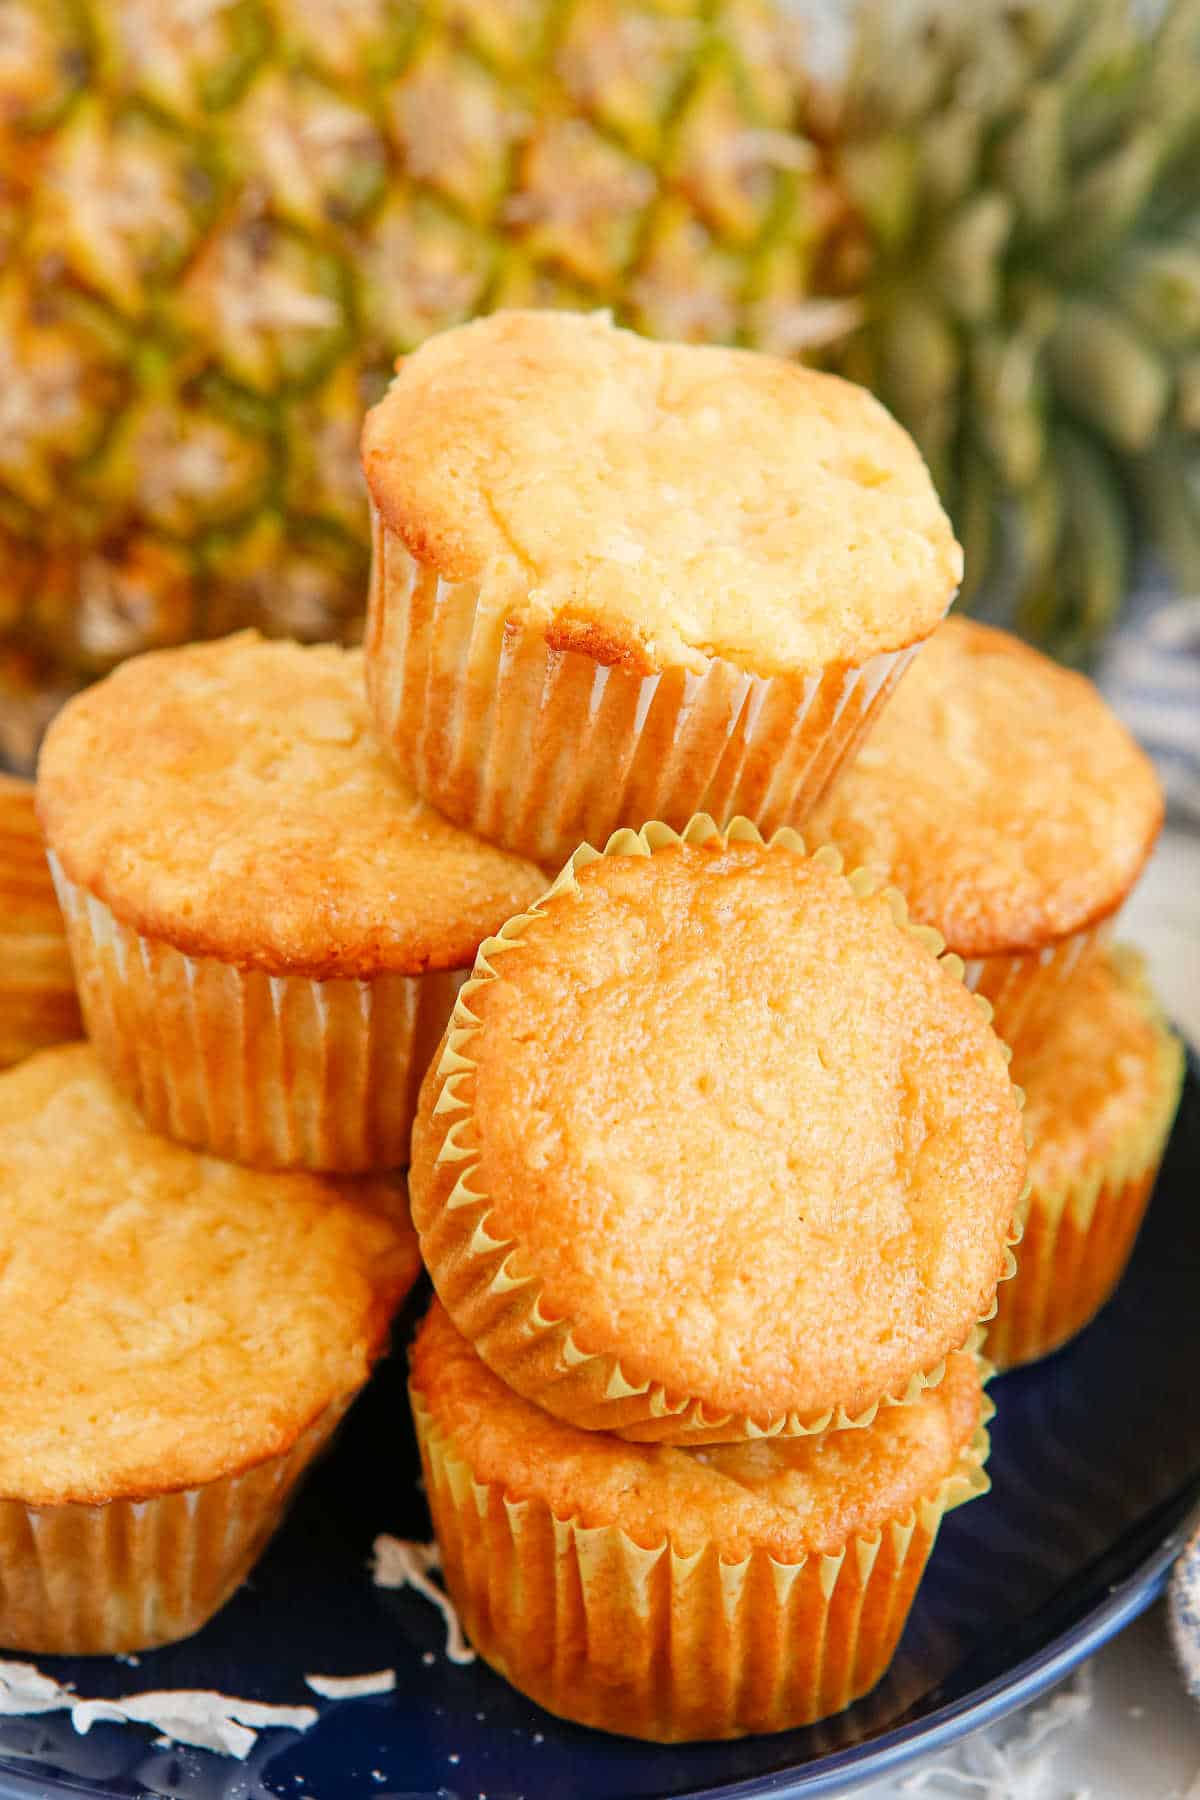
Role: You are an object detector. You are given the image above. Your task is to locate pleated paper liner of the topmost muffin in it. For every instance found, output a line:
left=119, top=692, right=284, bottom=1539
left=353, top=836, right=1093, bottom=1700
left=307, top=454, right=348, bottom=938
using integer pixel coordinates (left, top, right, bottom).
left=367, top=513, right=919, bottom=868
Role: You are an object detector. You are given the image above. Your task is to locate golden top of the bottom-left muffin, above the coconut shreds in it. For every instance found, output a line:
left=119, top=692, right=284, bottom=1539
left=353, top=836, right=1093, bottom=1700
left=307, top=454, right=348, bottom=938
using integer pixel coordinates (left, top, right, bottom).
left=0, top=1044, right=419, bottom=1505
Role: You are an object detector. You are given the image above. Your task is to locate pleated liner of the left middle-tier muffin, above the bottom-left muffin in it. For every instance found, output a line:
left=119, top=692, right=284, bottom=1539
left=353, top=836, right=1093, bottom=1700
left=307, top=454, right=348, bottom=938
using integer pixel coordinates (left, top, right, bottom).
left=50, top=857, right=466, bottom=1174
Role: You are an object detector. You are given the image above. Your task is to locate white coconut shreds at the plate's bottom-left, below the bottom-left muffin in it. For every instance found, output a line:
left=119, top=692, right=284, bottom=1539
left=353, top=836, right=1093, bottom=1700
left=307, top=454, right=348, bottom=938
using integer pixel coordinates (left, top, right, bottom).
left=0, top=1663, right=317, bottom=1760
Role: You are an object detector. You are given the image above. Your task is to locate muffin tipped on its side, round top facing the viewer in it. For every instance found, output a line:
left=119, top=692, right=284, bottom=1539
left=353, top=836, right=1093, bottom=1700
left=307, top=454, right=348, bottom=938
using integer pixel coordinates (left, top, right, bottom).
left=410, top=819, right=1025, bottom=1444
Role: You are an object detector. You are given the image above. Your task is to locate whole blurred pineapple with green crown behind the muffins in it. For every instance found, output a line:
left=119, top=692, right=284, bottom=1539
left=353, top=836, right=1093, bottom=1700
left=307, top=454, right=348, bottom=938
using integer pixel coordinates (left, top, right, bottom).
left=0, top=0, right=1200, bottom=767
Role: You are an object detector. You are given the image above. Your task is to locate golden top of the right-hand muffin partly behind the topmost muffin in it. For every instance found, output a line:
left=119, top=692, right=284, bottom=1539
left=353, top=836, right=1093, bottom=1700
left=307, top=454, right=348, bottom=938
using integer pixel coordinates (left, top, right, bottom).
left=804, top=619, right=1162, bottom=958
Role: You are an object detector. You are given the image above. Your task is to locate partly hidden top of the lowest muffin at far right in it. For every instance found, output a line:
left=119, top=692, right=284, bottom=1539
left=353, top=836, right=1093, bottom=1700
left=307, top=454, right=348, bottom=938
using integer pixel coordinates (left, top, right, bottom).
left=1018, top=947, right=1184, bottom=1195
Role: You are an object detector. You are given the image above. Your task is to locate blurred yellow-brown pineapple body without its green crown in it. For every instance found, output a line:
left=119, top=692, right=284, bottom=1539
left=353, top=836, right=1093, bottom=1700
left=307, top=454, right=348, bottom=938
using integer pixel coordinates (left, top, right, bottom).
left=0, top=0, right=851, bottom=765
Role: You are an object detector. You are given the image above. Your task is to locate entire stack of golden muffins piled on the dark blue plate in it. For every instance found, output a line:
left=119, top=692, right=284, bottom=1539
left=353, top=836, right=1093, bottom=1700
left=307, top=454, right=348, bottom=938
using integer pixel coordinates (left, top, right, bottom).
left=0, top=313, right=1178, bottom=1739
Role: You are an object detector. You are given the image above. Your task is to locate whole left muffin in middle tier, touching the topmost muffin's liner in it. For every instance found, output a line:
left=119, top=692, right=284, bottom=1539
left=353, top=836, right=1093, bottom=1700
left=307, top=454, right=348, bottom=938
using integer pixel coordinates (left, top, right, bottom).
left=38, top=632, right=545, bottom=1172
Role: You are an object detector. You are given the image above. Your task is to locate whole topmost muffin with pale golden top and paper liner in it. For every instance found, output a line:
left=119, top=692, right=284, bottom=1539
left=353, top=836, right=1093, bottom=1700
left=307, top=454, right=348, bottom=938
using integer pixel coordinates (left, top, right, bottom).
left=363, top=311, right=963, bottom=869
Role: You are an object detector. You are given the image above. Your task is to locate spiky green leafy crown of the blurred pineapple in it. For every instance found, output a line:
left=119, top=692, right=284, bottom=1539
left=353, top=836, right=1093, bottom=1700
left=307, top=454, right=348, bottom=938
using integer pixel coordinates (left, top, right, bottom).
left=833, top=0, right=1200, bottom=659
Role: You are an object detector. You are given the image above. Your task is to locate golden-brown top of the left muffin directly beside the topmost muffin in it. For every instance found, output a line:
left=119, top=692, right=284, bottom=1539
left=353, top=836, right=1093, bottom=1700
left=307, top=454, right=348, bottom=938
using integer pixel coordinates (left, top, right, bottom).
left=38, top=632, right=545, bottom=977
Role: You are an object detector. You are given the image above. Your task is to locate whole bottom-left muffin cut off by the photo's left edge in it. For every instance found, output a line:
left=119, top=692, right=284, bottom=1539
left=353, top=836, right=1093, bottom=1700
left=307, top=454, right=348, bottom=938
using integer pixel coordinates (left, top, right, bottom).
left=0, top=1044, right=417, bottom=1656
